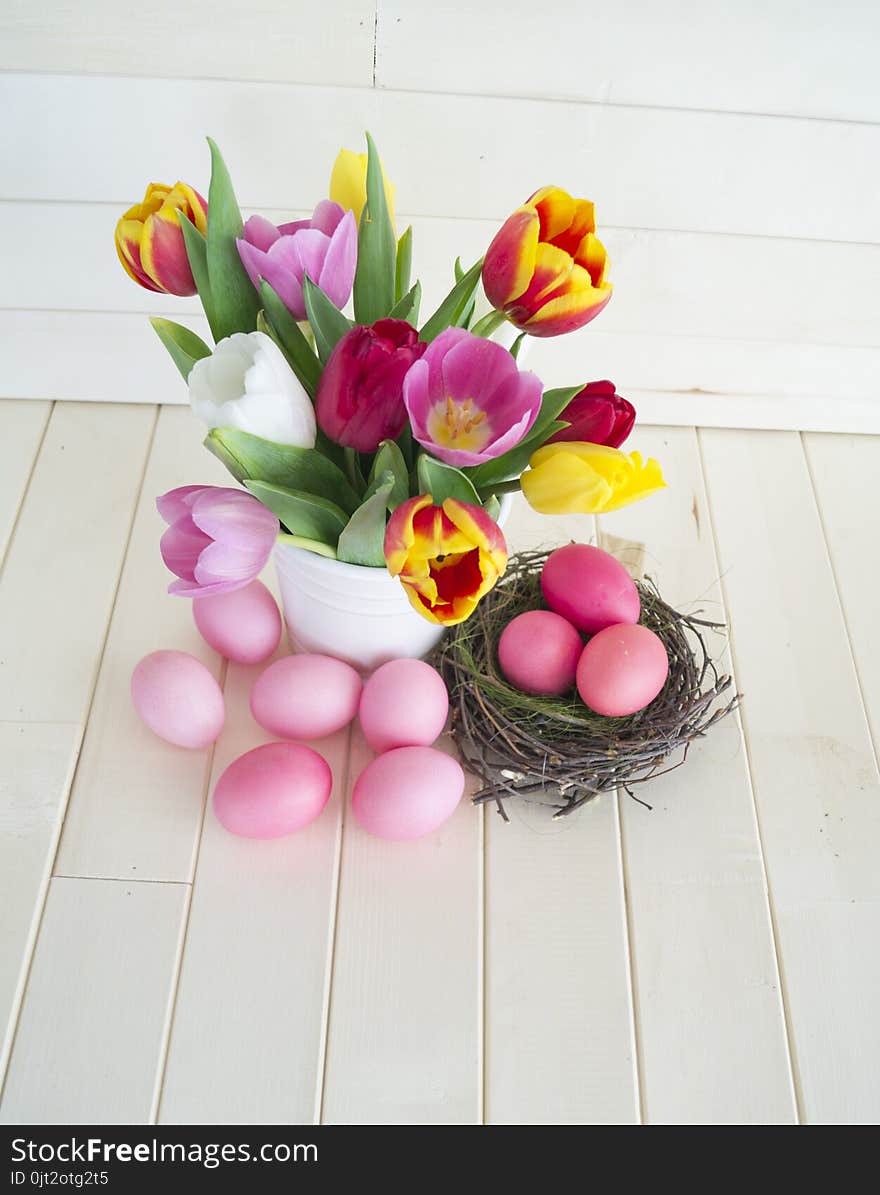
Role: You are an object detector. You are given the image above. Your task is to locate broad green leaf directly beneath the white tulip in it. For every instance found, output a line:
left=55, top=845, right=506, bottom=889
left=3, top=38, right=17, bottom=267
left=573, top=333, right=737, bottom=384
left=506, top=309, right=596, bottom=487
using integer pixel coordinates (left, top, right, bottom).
left=204, top=428, right=360, bottom=514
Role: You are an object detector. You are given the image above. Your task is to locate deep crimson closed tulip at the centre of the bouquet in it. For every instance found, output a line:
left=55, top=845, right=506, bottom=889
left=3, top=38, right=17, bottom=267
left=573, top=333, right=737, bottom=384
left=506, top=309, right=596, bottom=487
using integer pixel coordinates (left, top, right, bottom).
left=314, top=319, right=427, bottom=452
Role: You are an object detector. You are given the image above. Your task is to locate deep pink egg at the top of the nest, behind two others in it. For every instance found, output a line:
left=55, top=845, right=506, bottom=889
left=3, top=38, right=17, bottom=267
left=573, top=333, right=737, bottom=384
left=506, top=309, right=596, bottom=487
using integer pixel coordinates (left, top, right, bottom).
left=540, top=544, right=642, bottom=635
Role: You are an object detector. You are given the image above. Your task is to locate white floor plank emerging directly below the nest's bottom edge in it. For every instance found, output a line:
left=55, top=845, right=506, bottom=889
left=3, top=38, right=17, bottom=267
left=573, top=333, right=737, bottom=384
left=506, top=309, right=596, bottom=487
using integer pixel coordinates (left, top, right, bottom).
left=485, top=497, right=638, bottom=1124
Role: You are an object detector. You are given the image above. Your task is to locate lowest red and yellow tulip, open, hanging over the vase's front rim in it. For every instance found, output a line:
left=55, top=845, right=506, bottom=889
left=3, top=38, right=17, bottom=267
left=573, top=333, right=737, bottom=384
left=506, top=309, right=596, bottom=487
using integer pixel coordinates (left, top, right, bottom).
left=385, top=494, right=507, bottom=626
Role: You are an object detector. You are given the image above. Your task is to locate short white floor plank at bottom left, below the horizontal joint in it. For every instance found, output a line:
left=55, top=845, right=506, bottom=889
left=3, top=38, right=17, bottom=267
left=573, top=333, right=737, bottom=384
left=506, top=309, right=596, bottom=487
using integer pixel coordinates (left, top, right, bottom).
left=0, top=878, right=187, bottom=1124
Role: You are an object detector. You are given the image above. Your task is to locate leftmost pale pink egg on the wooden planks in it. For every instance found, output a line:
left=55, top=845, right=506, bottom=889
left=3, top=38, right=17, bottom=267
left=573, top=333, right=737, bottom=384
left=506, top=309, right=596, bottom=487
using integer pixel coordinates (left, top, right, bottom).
left=132, top=651, right=226, bottom=748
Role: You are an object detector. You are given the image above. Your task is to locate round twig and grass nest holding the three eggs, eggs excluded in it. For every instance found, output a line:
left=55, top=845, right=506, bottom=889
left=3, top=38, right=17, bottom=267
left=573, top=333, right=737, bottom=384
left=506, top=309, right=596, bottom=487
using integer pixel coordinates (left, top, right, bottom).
left=433, top=552, right=739, bottom=821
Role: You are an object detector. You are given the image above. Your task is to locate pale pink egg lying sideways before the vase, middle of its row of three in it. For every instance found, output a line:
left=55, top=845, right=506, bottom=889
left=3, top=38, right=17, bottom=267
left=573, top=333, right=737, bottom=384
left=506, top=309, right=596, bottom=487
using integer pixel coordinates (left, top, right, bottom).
left=251, top=655, right=362, bottom=739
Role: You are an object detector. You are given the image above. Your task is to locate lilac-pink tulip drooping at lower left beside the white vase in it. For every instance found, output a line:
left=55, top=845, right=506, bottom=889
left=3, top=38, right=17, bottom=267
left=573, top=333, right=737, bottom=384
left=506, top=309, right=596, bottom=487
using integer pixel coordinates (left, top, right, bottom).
left=155, top=485, right=279, bottom=598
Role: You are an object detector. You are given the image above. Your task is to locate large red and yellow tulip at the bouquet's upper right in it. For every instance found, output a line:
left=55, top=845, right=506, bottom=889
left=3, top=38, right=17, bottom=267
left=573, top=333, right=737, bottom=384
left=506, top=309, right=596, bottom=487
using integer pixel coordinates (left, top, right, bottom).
left=483, top=186, right=611, bottom=336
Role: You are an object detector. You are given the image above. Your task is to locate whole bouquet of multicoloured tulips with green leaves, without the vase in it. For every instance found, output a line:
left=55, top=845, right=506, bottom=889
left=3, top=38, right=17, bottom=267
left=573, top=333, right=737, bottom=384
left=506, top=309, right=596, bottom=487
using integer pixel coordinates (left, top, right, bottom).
left=116, top=135, right=664, bottom=625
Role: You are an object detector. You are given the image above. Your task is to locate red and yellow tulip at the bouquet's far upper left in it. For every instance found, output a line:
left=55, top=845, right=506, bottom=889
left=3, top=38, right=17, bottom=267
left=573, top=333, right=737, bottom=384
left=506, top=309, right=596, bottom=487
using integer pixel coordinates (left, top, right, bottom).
left=116, top=183, right=208, bottom=295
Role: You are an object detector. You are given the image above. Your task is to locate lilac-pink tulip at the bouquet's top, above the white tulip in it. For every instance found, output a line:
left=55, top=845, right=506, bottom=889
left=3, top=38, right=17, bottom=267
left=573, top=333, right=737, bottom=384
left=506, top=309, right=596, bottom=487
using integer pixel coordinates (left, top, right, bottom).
left=236, top=200, right=358, bottom=319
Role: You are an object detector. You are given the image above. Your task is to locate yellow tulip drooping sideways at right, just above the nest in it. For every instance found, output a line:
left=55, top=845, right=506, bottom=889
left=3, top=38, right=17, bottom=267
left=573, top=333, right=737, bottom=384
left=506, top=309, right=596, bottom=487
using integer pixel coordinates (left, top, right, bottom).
left=521, top=440, right=666, bottom=515
